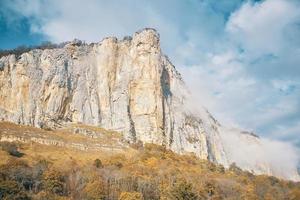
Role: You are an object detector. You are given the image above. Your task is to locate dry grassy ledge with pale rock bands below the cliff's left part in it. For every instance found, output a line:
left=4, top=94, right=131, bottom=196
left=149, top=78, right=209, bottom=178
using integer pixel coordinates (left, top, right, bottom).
left=0, top=122, right=127, bottom=150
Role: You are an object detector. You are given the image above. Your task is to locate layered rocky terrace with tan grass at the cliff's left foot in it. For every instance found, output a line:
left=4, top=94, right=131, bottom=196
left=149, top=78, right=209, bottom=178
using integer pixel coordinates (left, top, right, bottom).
left=0, top=122, right=125, bottom=152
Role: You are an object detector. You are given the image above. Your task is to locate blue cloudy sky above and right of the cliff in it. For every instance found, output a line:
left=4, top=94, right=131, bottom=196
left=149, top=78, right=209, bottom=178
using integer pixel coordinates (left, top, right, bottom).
left=0, top=0, right=300, bottom=146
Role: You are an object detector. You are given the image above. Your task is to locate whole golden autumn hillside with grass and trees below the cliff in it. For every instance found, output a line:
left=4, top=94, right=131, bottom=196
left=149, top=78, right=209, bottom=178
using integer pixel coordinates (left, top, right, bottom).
left=0, top=122, right=300, bottom=200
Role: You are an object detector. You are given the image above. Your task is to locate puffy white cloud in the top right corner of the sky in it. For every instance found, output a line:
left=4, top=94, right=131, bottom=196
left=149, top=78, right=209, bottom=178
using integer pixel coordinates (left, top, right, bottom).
left=226, top=0, right=300, bottom=55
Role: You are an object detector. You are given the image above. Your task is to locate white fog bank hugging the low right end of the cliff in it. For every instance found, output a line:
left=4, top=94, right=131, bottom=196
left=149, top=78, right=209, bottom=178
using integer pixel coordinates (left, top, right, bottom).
left=221, top=129, right=300, bottom=181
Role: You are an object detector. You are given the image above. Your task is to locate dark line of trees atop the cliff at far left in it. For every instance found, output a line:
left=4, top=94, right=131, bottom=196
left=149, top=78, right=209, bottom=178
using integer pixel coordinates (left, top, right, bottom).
left=0, top=41, right=67, bottom=58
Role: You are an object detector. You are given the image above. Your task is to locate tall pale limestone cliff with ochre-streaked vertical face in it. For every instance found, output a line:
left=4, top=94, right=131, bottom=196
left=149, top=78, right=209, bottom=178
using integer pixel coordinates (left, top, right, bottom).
left=0, top=29, right=299, bottom=180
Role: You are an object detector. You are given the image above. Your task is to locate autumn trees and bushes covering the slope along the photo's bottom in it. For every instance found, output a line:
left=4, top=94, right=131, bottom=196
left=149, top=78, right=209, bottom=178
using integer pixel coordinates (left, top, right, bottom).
left=0, top=143, right=300, bottom=200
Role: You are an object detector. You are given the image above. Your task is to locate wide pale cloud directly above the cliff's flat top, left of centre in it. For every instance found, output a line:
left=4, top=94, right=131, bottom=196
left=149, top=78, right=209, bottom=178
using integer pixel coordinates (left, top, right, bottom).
left=0, top=0, right=152, bottom=42
